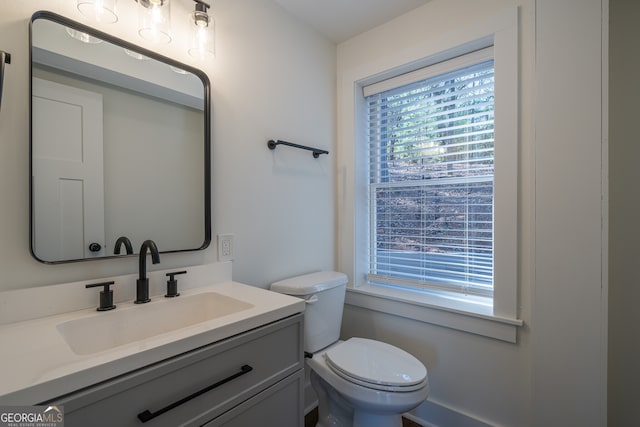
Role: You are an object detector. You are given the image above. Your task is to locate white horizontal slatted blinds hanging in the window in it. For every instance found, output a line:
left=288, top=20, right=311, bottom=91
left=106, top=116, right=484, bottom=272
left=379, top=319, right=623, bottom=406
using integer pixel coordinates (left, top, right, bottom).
left=365, top=48, right=494, bottom=296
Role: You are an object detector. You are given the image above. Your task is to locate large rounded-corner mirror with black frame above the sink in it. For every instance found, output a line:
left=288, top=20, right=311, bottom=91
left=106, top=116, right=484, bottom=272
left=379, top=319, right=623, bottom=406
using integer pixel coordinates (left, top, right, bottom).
left=30, top=12, right=211, bottom=263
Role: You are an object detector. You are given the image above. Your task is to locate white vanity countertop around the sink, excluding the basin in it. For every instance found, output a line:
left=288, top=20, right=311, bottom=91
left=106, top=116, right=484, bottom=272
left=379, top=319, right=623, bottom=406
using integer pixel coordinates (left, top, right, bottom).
left=0, top=281, right=305, bottom=405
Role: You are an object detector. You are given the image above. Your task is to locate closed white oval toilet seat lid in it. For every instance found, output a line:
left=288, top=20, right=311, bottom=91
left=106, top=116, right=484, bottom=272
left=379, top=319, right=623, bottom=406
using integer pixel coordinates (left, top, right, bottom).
left=324, top=338, right=427, bottom=392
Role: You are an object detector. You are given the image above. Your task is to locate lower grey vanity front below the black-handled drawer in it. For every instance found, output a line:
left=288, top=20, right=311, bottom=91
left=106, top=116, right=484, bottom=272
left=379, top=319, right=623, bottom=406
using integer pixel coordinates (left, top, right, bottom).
left=204, top=371, right=304, bottom=427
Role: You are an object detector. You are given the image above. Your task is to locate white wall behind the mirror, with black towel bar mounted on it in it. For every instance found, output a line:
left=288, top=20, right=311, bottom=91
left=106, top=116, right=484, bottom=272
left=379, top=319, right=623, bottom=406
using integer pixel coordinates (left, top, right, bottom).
left=0, top=0, right=335, bottom=292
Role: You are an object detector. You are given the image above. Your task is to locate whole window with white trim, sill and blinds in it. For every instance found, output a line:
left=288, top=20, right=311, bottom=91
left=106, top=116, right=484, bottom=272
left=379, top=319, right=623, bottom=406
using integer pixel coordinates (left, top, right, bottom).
left=338, top=13, right=520, bottom=342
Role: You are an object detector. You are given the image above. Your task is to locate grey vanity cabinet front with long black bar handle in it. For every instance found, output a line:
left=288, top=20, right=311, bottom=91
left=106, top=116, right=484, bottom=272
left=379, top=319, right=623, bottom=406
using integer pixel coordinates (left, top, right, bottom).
left=43, top=314, right=304, bottom=427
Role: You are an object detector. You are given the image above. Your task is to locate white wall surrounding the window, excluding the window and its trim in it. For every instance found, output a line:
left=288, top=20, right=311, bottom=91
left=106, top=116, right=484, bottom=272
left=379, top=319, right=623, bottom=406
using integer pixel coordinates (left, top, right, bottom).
left=337, top=0, right=606, bottom=427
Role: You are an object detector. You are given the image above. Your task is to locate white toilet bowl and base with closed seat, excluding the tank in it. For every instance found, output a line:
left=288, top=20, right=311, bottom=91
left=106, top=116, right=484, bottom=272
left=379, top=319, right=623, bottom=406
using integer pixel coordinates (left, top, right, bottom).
left=307, top=338, right=429, bottom=427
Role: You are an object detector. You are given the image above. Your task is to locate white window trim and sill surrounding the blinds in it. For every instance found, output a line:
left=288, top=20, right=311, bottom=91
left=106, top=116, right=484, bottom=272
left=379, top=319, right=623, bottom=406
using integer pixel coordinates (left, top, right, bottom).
left=339, top=8, right=523, bottom=342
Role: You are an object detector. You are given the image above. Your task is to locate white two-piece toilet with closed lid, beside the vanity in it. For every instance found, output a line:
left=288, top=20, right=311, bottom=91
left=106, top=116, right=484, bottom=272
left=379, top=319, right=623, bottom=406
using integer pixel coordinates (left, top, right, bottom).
left=271, top=271, right=429, bottom=427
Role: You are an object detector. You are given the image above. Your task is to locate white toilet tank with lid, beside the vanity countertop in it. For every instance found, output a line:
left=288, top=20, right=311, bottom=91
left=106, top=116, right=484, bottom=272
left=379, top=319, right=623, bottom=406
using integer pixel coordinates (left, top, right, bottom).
left=271, top=271, right=347, bottom=353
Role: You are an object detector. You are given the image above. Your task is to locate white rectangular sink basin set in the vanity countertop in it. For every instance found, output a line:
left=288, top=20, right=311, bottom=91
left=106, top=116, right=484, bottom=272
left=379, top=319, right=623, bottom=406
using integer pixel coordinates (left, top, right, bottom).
left=57, top=292, right=254, bottom=355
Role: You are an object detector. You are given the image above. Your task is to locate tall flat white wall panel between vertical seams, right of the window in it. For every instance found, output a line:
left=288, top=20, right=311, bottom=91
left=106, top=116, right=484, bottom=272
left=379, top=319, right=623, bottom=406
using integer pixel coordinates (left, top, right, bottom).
left=531, top=0, right=608, bottom=426
